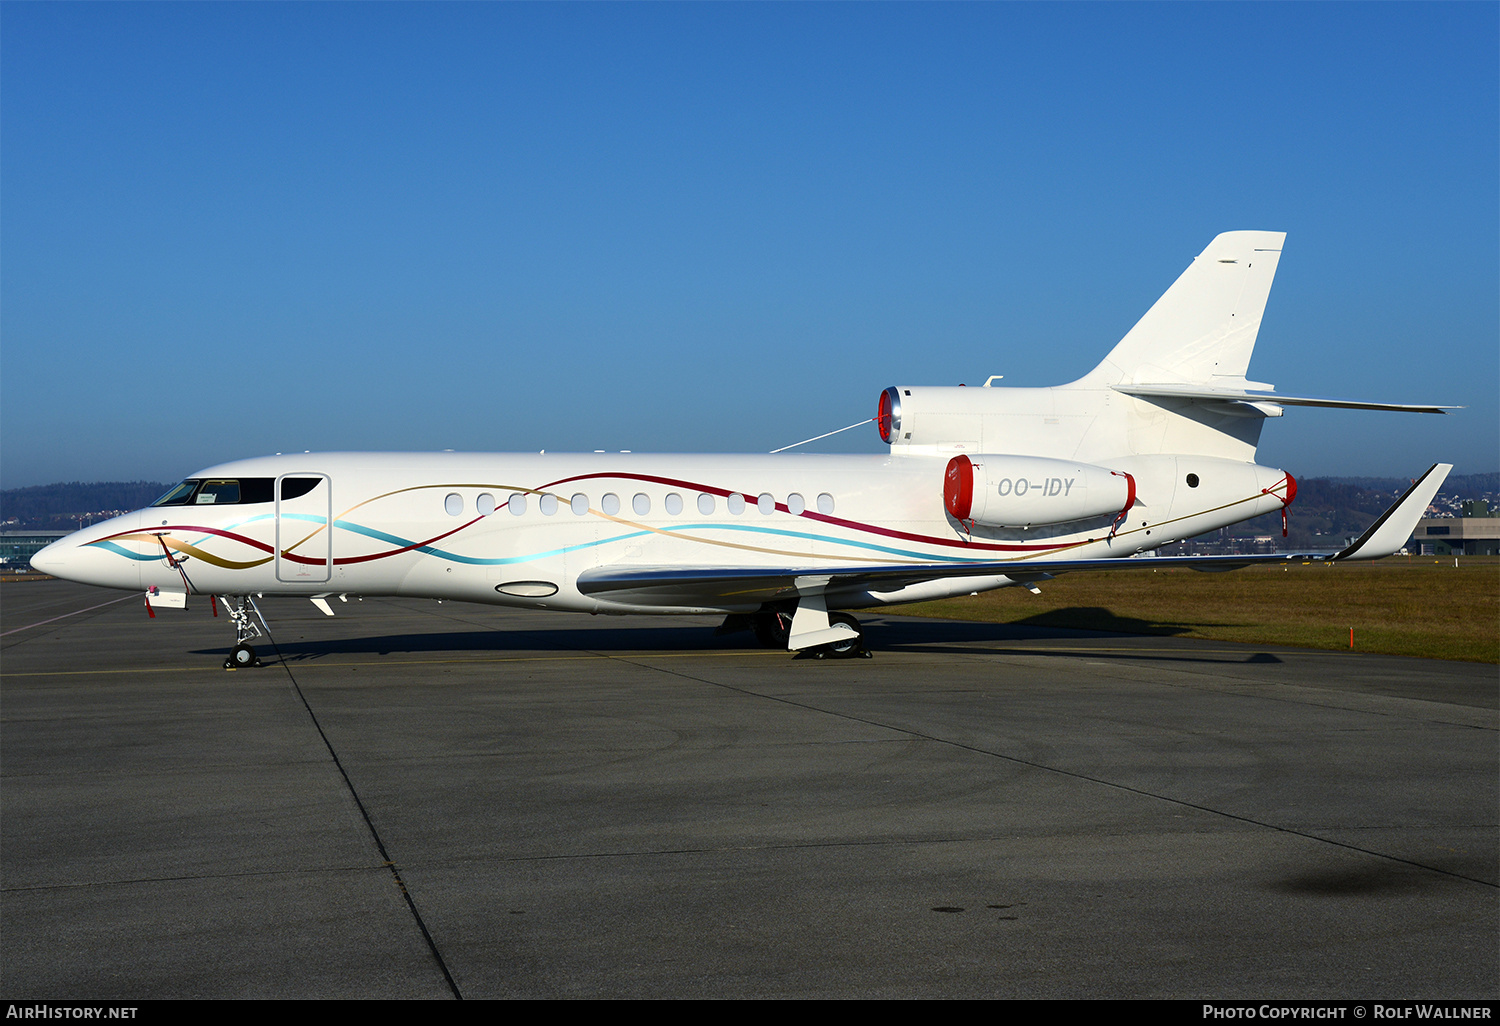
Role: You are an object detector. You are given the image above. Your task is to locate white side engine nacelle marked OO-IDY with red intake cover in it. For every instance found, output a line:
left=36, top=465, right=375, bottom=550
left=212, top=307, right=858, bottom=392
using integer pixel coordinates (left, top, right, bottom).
left=942, top=456, right=1136, bottom=528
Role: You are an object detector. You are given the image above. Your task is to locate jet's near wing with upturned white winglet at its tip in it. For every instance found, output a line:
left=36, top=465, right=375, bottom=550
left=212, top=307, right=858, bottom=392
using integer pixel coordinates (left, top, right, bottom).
left=578, top=464, right=1452, bottom=606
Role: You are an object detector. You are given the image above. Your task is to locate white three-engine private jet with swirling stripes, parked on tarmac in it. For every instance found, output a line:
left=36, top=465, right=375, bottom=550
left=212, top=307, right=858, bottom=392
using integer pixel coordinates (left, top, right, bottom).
left=32, top=231, right=1452, bottom=668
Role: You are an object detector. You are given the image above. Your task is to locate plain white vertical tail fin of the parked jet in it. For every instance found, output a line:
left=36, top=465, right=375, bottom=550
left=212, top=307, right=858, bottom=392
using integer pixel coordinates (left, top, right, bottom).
left=1083, top=231, right=1287, bottom=386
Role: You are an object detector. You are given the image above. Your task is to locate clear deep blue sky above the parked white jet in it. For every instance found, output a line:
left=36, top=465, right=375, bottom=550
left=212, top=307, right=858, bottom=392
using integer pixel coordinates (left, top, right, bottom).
left=0, top=2, right=1500, bottom=488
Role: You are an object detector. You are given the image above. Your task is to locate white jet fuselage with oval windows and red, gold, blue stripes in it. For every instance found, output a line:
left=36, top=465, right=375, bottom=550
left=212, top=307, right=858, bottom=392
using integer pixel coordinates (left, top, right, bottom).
left=35, top=453, right=1295, bottom=614
